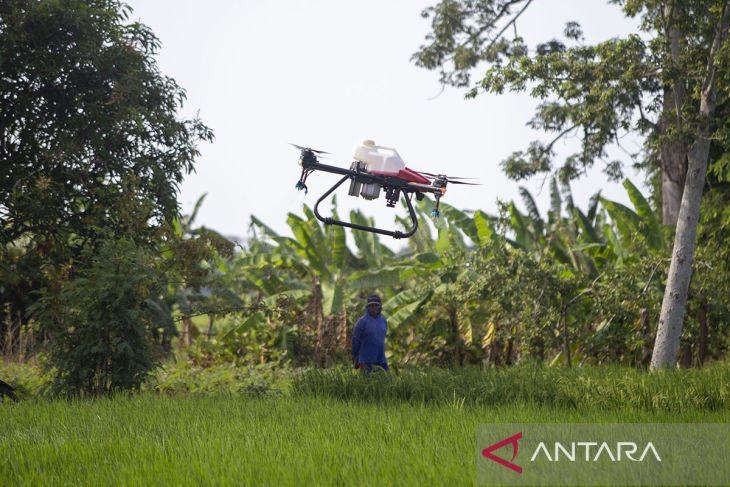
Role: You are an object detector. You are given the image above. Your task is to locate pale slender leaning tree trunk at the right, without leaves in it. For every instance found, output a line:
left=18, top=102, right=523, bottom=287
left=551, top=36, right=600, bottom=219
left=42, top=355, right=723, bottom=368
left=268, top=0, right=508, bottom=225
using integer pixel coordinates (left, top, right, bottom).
left=651, top=5, right=728, bottom=369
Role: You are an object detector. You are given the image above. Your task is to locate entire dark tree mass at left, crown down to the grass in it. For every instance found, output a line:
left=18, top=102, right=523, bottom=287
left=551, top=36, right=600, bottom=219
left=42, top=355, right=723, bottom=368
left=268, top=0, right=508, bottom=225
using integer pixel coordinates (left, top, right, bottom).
left=0, top=0, right=213, bottom=392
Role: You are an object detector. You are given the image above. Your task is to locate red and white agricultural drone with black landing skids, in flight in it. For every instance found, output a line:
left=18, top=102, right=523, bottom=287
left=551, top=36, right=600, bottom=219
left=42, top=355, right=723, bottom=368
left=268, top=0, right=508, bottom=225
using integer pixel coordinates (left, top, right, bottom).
left=291, top=140, right=479, bottom=239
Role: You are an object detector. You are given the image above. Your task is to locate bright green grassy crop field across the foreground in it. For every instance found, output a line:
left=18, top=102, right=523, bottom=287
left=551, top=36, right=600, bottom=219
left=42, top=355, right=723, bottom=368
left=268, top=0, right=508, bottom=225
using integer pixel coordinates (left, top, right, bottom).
left=0, top=367, right=730, bottom=485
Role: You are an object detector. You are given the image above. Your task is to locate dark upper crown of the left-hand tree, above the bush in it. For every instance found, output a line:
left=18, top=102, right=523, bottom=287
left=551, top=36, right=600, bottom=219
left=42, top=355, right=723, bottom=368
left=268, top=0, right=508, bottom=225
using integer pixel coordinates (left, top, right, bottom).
left=0, top=0, right=212, bottom=247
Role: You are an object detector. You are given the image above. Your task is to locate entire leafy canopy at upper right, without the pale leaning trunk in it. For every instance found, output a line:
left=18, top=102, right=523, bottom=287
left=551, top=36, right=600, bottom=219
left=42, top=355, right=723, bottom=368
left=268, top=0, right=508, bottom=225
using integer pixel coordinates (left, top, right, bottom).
left=412, top=0, right=730, bottom=194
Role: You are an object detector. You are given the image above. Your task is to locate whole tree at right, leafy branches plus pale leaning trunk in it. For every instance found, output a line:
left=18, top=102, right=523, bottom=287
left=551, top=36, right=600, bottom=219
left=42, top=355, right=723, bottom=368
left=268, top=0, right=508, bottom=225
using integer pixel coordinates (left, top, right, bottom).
left=413, top=0, right=730, bottom=367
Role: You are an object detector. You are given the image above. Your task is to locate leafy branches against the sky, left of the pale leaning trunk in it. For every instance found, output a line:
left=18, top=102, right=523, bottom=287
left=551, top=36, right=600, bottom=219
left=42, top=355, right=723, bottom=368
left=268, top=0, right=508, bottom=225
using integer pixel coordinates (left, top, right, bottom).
left=413, top=0, right=660, bottom=181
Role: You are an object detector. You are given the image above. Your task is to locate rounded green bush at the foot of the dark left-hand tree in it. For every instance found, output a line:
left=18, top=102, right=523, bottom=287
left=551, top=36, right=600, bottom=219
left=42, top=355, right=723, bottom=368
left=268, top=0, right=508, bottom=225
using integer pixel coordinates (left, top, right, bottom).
left=36, top=239, right=160, bottom=395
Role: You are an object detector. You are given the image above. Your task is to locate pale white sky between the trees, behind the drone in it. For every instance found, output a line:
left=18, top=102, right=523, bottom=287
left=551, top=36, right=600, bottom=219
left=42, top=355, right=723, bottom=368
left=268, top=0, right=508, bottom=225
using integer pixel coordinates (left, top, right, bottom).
left=127, top=0, right=643, bottom=248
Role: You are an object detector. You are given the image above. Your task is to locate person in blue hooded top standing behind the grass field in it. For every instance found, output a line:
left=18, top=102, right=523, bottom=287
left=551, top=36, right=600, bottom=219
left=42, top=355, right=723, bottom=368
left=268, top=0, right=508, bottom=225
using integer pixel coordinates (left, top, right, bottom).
left=352, top=295, right=389, bottom=372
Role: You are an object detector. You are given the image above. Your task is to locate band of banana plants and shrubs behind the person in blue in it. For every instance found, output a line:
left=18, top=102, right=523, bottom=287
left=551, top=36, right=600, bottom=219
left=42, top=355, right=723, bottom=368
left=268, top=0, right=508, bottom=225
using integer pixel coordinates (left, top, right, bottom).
left=5, top=180, right=730, bottom=392
